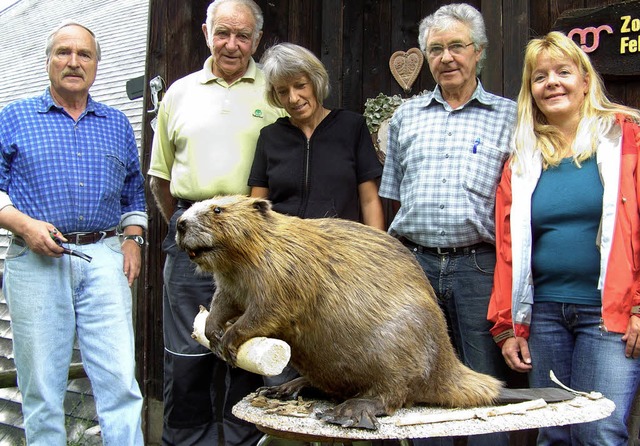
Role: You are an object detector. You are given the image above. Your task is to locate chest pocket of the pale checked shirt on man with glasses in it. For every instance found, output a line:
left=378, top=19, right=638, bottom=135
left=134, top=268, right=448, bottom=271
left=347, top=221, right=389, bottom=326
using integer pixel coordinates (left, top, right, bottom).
left=462, top=139, right=509, bottom=199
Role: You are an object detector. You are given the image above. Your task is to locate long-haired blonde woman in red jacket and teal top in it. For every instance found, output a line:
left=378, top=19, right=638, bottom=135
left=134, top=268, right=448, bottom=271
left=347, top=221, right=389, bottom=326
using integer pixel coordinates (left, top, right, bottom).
left=488, top=32, right=640, bottom=446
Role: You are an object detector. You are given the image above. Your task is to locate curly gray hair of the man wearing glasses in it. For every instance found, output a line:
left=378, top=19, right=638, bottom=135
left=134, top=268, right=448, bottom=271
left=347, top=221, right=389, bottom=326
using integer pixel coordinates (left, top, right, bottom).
left=418, top=3, right=489, bottom=74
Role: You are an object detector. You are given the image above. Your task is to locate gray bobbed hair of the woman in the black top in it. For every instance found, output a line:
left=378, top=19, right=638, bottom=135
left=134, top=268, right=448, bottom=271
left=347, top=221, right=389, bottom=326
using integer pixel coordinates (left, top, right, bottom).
left=260, top=43, right=329, bottom=107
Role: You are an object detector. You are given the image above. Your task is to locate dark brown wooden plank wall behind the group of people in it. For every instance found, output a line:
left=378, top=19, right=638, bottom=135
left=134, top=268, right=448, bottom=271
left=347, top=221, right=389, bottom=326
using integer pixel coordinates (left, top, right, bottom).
left=137, top=0, right=640, bottom=412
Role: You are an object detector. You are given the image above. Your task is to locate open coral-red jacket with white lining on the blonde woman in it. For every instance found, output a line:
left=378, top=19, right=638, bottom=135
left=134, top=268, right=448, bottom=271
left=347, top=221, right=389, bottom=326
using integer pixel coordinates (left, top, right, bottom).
left=487, top=116, right=640, bottom=346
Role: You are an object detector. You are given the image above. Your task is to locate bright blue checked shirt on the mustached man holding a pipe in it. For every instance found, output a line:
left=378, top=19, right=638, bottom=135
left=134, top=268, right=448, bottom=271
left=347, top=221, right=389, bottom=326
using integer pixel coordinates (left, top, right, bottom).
left=0, top=88, right=147, bottom=233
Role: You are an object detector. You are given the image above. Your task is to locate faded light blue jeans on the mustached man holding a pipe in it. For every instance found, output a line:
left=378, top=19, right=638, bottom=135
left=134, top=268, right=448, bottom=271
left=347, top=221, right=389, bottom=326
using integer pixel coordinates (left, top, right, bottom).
left=4, top=237, right=143, bottom=446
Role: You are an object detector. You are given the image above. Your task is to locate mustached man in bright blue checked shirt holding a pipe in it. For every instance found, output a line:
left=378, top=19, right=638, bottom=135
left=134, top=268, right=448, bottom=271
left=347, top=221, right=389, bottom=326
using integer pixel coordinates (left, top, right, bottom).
left=0, top=22, right=147, bottom=446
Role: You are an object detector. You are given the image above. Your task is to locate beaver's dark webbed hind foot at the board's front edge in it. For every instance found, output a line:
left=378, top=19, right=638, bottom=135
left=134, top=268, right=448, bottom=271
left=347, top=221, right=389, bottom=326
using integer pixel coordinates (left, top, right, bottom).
left=316, top=398, right=386, bottom=430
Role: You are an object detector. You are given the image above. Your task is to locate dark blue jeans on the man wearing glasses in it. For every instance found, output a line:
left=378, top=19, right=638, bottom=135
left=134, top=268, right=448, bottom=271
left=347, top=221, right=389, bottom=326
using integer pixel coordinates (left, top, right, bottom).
left=412, top=243, right=509, bottom=446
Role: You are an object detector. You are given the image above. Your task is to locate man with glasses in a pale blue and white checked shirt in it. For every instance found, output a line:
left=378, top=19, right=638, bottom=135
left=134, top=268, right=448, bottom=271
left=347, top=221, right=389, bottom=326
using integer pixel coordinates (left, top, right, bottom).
left=379, top=4, right=516, bottom=446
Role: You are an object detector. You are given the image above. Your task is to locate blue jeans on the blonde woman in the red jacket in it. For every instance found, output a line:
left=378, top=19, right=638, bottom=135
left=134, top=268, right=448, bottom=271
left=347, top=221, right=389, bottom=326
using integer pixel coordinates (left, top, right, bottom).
left=529, top=302, right=640, bottom=446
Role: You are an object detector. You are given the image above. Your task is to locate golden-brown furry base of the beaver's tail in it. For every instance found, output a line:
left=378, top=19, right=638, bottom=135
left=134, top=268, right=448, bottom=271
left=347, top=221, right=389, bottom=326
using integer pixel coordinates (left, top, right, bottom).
left=431, top=363, right=504, bottom=407
